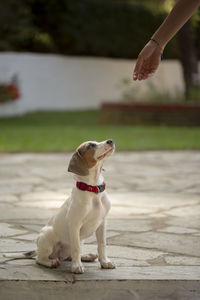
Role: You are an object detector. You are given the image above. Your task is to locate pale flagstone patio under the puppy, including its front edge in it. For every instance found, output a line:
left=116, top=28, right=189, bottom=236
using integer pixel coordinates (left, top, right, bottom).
left=0, top=151, right=200, bottom=300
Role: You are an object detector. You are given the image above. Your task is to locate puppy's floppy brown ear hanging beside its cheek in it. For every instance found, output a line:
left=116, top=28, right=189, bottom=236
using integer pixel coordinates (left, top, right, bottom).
left=68, top=150, right=89, bottom=176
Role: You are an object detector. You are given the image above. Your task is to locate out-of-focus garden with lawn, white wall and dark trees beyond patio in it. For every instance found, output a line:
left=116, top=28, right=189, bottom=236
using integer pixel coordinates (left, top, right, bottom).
left=0, top=0, right=200, bottom=152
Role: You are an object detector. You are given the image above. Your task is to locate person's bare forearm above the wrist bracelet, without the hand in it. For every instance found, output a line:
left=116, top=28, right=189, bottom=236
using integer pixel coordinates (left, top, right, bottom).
left=152, top=0, right=200, bottom=48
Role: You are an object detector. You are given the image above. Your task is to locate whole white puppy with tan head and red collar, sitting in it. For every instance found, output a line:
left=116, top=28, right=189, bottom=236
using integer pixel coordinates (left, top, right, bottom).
left=4, top=140, right=115, bottom=273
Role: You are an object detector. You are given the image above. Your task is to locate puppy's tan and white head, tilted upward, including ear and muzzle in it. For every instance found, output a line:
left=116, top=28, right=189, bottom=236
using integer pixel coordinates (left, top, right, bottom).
left=68, top=140, right=115, bottom=176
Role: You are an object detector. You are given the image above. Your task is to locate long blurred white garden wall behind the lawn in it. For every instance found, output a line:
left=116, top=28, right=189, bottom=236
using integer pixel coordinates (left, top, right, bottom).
left=0, top=53, right=186, bottom=116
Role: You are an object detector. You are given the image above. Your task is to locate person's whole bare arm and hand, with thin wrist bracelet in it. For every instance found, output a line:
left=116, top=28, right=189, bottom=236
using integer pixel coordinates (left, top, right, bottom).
left=133, top=0, right=200, bottom=80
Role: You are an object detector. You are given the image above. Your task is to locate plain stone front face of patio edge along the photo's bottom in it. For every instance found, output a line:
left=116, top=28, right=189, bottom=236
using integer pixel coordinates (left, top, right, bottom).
left=0, top=280, right=200, bottom=300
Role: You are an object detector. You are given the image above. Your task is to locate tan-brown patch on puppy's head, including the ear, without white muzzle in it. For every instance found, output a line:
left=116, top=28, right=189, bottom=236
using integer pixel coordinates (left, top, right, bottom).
left=68, top=142, right=97, bottom=176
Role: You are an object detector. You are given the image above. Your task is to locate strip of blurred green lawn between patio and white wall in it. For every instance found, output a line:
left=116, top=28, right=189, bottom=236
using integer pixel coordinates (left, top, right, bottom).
left=0, top=110, right=200, bottom=152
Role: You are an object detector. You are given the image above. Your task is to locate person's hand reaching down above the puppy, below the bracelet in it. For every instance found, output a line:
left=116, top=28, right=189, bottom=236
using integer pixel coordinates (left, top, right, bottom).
left=133, top=40, right=163, bottom=80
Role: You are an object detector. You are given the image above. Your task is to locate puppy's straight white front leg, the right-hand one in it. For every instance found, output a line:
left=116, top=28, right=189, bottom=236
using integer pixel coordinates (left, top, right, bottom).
left=96, top=219, right=115, bottom=269
